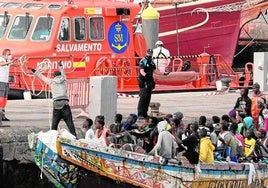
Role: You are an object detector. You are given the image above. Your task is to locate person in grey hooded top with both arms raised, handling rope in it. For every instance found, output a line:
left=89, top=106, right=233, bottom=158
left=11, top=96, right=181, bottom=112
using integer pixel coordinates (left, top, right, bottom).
left=31, top=62, right=76, bottom=136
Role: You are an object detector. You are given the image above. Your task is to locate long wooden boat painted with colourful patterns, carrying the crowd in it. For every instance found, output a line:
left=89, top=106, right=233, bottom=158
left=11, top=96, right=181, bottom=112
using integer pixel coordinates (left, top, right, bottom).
left=28, top=129, right=268, bottom=188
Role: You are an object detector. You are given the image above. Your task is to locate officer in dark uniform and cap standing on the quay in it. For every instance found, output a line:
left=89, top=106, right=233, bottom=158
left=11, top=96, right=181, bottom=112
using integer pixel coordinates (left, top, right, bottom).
left=138, top=49, right=169, bottom=118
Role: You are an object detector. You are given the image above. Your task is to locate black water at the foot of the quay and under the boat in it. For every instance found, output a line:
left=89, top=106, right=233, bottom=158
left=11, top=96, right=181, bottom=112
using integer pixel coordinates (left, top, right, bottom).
left=0, top=161, right=137, bottom=188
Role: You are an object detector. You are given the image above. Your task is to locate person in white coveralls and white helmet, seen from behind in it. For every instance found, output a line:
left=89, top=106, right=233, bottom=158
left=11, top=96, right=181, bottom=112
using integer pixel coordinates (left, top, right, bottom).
left=153, top=40, right=170, bottom=72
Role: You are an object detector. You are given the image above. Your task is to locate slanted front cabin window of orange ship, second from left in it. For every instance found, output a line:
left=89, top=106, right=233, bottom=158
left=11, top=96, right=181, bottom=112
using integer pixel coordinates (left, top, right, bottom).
left=8, top=14, right=33, bottom=39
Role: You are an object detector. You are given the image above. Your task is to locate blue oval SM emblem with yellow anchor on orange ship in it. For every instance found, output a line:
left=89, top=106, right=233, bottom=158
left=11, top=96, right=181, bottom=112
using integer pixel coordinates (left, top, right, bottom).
left=108, top=22, right=129, bottom=54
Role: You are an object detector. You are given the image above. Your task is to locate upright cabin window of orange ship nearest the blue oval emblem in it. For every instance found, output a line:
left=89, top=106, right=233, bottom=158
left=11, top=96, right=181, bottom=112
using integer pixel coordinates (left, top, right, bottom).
left=89, top=17, right=104, bottom=41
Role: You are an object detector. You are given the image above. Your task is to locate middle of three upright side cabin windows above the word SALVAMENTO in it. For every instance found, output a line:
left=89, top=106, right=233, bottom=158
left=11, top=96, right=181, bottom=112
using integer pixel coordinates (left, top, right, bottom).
left=74, top=17, right=86, bottom=41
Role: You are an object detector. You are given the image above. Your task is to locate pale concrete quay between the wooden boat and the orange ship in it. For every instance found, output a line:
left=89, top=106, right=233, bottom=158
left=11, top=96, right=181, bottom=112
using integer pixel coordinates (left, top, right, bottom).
left=0, top=91, right=243, bottom=161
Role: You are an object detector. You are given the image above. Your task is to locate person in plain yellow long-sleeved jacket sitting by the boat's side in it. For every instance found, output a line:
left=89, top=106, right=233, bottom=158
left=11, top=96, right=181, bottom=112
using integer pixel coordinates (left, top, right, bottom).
left=199, top=128, right=215, bottom=163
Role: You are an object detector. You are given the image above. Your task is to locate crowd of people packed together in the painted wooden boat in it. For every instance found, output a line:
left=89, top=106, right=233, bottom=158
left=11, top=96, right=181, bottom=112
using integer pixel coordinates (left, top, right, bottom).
left=79, top=83, right=268, bottom=164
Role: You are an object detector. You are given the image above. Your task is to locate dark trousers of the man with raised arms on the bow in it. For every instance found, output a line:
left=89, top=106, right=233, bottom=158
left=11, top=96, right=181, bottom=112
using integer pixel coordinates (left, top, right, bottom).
left=52, top=105, right=76, bottom=136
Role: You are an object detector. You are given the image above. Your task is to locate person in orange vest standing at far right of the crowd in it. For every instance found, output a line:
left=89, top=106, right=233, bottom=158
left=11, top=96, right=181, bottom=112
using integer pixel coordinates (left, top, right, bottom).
left=251, top=82, right=265, bottom=128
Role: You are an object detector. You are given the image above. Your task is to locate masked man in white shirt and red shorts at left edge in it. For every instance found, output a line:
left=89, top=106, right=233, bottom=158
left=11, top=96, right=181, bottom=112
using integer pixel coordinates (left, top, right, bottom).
left=0, top=49, right=13, bottom=126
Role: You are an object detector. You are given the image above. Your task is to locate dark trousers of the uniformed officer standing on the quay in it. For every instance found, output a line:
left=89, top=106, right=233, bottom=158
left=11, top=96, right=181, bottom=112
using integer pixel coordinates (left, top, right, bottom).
left=138, top=88, right=152, bottom=117
